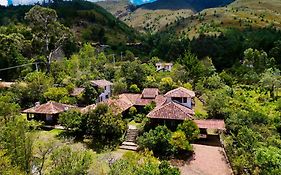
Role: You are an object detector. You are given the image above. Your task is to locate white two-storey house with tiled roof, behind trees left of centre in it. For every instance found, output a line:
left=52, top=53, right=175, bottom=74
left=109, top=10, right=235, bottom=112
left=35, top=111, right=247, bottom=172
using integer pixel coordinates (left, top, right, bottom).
left=91, top=80, right=113, bottom=102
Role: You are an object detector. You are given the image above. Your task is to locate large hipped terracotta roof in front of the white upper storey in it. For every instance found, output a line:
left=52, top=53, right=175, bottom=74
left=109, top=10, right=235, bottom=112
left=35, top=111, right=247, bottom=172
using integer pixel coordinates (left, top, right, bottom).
left=147, top=101, right=194, bottom=120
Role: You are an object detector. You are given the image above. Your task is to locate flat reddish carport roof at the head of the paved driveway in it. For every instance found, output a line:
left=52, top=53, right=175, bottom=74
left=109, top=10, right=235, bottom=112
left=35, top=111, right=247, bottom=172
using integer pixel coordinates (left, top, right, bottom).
left=194, top=119, right=225, bottom=130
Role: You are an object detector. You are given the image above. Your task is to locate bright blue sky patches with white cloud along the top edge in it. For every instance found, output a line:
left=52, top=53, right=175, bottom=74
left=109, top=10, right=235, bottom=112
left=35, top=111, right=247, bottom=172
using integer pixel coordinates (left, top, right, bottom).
left=0, top=0, right=157, bottom=6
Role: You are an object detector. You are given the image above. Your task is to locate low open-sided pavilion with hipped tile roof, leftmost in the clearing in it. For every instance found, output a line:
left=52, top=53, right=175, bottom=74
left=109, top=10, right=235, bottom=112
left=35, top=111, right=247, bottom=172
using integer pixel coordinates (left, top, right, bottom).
left=22, top=102, right=76, bottom=125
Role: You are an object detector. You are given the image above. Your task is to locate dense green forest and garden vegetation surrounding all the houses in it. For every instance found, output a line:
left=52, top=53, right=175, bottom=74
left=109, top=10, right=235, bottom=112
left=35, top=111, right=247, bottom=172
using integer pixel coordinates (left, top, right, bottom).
left=0, top=1, right=281, bottom=175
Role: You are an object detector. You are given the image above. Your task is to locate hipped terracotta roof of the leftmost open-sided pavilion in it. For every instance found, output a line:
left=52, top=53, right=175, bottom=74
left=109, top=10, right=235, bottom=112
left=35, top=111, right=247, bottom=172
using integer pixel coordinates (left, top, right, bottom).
left=22, top=102, right=75, bottom=114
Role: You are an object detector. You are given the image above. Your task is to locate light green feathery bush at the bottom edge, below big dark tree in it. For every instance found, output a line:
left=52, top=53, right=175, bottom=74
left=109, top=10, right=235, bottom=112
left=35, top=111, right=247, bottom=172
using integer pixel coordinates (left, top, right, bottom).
left=49, top=145, right=92, bottom=175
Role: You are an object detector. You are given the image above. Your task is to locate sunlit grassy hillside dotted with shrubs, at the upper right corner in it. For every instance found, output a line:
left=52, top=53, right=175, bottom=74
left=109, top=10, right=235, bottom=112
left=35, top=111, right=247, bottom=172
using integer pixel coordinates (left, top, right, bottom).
left=165, top=0, right=281, bottom=37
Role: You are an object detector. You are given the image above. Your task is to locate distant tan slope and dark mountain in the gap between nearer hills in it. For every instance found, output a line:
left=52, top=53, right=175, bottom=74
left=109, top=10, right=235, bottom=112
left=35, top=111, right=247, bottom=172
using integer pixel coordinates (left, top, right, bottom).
left=98, top=0, right=232, bottom=32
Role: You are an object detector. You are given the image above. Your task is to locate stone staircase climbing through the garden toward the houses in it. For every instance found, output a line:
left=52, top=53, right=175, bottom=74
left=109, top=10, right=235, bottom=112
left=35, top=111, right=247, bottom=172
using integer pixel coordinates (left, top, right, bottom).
left=120, top=126, right=139, bottom=151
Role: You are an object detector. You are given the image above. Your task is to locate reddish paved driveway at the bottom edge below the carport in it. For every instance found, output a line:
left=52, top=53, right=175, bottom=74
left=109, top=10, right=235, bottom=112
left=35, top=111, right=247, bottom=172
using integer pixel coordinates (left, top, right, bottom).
left=179, top=144, right=232, bottom=175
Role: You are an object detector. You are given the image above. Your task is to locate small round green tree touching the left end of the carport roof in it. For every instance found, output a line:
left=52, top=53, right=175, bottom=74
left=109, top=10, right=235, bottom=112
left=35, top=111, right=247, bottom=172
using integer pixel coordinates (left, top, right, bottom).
left=177, top=120, right=200, bottom=142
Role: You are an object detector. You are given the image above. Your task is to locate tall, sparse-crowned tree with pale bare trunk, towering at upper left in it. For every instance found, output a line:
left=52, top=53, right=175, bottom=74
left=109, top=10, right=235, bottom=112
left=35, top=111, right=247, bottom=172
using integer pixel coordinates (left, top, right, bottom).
left=25, top=5, right=72, bottom=73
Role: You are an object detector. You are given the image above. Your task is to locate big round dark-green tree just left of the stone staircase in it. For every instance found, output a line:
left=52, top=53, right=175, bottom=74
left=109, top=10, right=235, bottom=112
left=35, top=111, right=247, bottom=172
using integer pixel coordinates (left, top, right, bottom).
left=85, top=104, right=127, bottom=145
